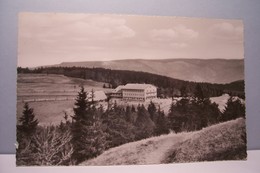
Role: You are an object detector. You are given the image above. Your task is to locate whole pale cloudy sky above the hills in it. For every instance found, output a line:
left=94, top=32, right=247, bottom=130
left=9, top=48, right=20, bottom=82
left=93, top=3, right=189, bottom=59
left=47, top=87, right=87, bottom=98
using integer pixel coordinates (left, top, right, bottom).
left=18, top=13, right=244, bottom=67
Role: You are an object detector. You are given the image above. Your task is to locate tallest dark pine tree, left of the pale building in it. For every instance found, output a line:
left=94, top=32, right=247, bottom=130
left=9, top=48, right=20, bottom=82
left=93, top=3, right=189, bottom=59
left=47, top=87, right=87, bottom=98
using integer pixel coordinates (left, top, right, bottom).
left=71, top=87, right=102, bottom=164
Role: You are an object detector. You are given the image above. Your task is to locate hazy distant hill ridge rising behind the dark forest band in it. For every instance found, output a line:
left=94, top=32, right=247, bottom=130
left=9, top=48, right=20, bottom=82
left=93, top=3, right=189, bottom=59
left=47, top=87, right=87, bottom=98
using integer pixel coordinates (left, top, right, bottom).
left=54, top=59, right=244, bottom=83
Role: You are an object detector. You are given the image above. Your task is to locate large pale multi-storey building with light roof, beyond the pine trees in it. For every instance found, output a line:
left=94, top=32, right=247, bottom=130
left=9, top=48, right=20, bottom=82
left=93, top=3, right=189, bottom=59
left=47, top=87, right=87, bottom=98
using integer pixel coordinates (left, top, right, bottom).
left=111, top=83, right=157, bottom=101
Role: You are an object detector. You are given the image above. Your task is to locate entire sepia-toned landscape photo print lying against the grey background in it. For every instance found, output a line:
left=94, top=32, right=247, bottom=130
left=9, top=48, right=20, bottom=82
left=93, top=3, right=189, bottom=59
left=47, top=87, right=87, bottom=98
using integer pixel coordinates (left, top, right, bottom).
left=16, top=12, right=247, bottom=166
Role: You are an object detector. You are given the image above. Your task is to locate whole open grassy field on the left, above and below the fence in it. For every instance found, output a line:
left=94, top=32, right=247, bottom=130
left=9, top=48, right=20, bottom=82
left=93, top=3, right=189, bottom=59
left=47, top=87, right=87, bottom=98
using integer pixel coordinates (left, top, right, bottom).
left=17, top=74, right=109, bottom=125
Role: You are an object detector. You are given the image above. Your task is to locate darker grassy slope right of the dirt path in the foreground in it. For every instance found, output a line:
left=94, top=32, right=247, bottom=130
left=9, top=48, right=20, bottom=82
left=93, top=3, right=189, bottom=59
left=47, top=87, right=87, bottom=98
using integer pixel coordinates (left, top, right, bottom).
left=163, top=118, right=246, bottom=163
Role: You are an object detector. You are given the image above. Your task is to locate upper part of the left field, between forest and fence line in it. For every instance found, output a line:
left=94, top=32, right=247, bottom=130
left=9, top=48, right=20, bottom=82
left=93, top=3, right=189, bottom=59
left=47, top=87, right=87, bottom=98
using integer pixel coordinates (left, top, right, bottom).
left=17, top=74, right=108, bottom=99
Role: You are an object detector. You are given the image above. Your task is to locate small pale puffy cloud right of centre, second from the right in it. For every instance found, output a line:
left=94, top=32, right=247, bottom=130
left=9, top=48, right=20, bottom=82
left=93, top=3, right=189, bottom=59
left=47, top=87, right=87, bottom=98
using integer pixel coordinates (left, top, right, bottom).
left=150, top=25, right=199, bottom=41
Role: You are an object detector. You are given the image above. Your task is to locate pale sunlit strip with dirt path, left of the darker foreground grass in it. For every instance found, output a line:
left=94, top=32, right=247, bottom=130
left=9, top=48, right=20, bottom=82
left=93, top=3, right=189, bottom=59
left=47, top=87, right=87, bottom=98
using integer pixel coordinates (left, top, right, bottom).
left=80, top=134, right=187, bottom=165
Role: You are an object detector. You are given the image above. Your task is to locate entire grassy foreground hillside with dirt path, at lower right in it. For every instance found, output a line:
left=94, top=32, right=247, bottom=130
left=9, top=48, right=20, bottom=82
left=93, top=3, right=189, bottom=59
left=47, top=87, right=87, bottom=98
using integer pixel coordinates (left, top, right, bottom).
left=81, top=118, right=246, bottom=165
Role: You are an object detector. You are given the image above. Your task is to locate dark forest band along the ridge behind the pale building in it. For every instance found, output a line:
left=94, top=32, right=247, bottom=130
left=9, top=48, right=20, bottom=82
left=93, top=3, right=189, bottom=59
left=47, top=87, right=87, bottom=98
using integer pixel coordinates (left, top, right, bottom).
left=17, top=67, right=245, bottom=98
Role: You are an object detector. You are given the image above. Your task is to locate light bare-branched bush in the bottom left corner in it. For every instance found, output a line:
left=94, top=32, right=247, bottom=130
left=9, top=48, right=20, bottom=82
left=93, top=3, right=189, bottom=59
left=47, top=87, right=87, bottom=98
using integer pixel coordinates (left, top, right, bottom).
left=16, top=126, right=73, bottom=166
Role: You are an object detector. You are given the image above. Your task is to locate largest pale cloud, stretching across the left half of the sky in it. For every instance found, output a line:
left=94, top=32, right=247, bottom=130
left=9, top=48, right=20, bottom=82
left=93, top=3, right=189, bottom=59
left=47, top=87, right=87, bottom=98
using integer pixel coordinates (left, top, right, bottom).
left=20, top=14, right=135, bottom=41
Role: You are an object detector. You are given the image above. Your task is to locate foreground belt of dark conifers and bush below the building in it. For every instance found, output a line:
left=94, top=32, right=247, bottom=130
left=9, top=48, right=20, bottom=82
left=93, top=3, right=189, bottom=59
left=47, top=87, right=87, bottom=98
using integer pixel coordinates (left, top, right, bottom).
left=16, top=85, right=245, bottom=165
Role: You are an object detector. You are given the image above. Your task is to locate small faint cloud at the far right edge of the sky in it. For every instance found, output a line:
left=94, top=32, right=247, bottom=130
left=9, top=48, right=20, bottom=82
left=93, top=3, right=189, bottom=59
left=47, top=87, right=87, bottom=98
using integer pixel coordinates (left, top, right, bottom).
left=210, top=22, right=243, bottom=39
